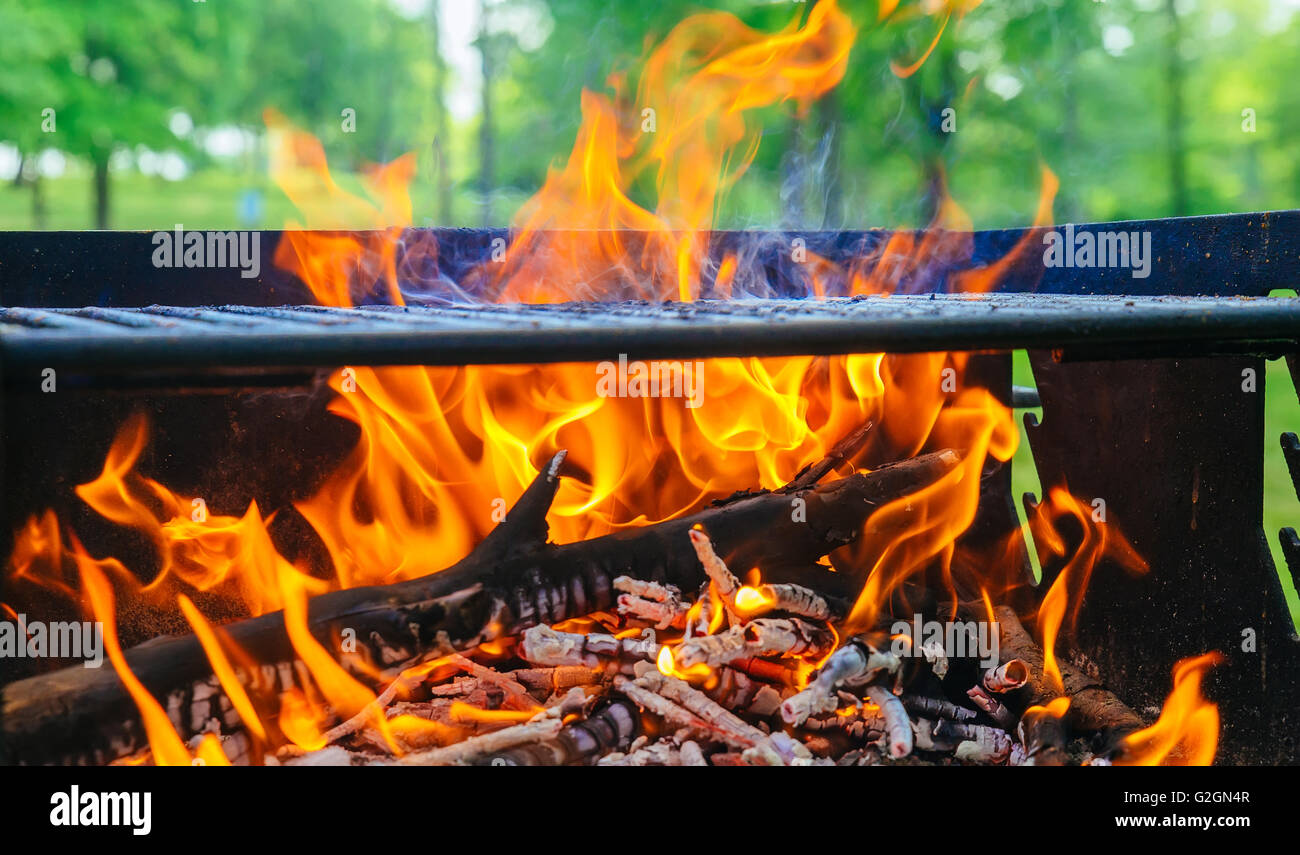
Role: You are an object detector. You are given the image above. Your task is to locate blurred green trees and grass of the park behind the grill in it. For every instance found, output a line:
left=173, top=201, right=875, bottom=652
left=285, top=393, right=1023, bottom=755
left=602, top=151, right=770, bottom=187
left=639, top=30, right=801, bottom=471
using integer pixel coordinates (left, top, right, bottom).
left=0, top=0, right=1300, bottom=609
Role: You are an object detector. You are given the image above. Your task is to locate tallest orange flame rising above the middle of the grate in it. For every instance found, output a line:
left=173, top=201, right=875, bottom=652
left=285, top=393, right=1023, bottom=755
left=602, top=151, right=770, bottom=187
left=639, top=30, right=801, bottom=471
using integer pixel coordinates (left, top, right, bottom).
left=490, top=0, right=857, bottom=303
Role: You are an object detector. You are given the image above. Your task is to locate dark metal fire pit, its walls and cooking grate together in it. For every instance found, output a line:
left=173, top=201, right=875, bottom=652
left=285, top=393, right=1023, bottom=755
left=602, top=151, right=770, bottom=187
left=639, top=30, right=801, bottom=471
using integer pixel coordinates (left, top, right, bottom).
left=0, top=212, right=1300, bottom=763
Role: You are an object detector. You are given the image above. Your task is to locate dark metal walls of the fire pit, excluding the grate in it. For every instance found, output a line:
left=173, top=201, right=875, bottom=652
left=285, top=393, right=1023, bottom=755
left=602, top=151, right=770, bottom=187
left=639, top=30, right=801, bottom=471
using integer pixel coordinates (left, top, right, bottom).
left=0, top=214, right=1300, bottom=763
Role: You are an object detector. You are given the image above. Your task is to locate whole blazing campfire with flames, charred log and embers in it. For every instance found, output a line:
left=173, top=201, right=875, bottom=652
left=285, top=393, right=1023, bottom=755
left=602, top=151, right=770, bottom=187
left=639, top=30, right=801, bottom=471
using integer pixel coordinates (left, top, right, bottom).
left=0, top=0, right=1295, bottom=765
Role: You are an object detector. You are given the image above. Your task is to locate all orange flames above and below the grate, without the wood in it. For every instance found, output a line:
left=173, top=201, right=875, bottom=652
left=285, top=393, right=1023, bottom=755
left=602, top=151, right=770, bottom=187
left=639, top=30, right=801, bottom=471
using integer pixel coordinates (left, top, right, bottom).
left=9, top=0, right=1217, bottom=764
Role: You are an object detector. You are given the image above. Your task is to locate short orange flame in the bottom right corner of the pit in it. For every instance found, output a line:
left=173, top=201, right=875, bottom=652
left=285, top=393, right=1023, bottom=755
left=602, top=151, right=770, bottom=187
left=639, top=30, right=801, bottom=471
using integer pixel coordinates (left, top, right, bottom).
left=1115, top=652, right=1225, bottom=765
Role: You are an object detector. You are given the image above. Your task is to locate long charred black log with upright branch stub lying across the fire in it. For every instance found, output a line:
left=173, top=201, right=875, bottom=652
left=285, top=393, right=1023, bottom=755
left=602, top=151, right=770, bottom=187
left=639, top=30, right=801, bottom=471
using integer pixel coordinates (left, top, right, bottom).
left=0, top=441, right=959, bottom=764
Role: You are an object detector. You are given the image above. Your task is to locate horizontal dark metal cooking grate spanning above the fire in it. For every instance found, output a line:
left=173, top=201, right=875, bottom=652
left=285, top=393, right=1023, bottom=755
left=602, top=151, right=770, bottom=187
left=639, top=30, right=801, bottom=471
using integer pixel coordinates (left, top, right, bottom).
left=0, top=294, right=1300, bottom=373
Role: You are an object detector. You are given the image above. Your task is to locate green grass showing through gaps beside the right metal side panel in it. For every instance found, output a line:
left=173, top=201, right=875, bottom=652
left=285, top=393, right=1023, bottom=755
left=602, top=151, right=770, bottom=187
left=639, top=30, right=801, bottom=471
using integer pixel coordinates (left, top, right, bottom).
left=1011, top=351, right=1300, bottom=626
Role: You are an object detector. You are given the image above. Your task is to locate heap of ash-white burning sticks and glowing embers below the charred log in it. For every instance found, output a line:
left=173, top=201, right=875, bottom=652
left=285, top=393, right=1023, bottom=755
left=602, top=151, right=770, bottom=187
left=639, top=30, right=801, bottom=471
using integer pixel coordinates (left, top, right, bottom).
left=253, top=530, right=1140, bottom=765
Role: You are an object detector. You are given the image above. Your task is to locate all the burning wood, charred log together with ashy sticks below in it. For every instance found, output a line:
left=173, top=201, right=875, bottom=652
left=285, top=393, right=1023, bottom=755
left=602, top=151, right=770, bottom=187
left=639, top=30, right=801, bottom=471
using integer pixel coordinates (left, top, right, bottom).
left=0, top=425, right=1144, bottom=765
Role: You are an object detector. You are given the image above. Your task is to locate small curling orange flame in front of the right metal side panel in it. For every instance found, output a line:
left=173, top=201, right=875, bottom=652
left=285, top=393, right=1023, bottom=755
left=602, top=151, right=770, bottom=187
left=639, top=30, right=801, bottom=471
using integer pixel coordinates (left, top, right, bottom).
left=1030, top=487, right=1149, bottom=690
